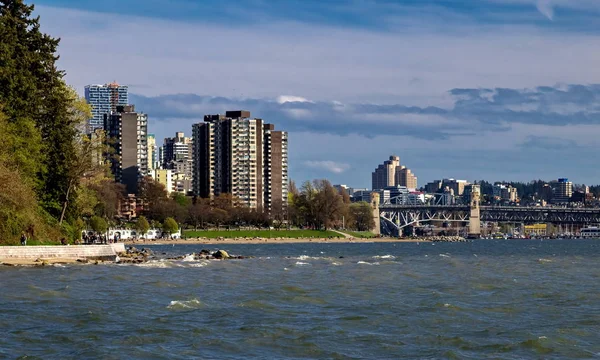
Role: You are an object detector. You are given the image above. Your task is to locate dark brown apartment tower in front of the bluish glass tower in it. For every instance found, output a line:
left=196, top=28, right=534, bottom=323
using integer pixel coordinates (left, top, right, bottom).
left=104, top=105, right=148, bottom=194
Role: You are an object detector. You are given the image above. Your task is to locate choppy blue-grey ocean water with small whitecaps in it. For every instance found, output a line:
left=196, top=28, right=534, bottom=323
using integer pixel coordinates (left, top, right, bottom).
left=0, top=240, right=600, bottom=359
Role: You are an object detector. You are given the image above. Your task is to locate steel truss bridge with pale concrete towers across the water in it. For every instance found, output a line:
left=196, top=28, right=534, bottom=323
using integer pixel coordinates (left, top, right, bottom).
left=371, top=187, right=600, bottom=236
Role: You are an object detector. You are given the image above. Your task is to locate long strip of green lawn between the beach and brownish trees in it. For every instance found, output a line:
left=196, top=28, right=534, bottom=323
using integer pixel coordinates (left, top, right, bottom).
left=184, top=230, right=342, bottom=239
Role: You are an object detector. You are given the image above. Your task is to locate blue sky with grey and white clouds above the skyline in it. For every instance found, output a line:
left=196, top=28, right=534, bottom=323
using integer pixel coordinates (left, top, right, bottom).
left=36, top=0, right=600, bottom=187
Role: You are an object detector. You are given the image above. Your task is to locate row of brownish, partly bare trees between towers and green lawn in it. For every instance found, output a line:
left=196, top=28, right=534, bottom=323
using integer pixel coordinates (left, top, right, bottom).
left=140, top=178, right=374, bottom=231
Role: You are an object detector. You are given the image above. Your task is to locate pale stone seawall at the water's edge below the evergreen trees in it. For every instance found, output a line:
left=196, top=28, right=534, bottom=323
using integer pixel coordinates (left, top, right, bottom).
left=0, top=243, right=125, bottom=261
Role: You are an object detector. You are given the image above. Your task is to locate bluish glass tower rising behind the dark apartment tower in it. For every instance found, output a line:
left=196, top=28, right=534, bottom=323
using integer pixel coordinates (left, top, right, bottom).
left=85, top=82, right=129, bottom=133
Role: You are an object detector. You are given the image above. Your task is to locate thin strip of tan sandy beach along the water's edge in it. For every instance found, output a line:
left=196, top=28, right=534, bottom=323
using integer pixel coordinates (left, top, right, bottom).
left=125, top=238, right=429, bottom=245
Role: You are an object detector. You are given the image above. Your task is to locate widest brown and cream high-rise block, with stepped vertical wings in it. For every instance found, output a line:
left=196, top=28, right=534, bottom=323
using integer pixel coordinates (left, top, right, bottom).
left=192, top=111, right=288, bottom=211
